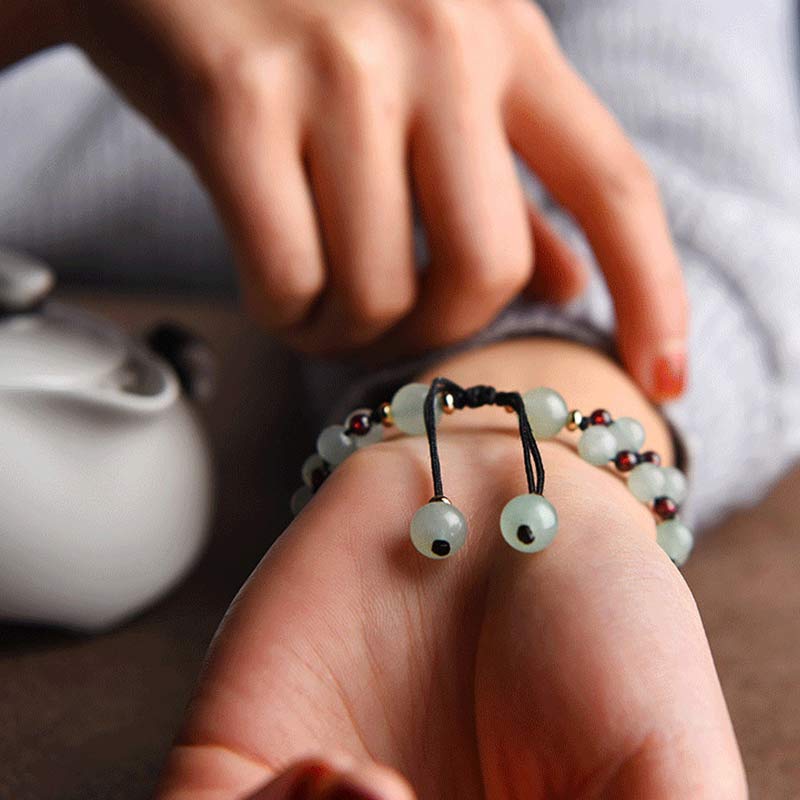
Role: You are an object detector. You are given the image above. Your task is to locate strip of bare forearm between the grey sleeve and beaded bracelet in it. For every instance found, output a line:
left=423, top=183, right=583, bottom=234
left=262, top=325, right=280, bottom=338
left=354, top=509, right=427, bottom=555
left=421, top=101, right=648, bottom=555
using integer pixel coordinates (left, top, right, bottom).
left=420, top=338, right=674, bottom=464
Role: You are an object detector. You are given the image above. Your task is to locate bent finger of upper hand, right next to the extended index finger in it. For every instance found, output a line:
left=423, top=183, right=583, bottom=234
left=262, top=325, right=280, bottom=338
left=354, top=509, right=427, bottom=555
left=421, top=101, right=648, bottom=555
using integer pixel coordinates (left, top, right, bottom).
left=405, top=114, right=533, bottom=346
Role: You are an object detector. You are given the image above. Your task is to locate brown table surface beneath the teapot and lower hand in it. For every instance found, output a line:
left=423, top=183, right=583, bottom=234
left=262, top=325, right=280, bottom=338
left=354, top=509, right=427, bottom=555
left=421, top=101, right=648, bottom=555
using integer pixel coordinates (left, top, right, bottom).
left=0, top=295, right=800, bottom=800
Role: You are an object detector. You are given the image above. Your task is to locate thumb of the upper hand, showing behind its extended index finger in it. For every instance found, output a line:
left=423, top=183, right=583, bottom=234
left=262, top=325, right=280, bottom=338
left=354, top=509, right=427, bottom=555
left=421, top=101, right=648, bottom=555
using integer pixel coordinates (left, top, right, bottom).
left=525, top=206, right=588, bottom=303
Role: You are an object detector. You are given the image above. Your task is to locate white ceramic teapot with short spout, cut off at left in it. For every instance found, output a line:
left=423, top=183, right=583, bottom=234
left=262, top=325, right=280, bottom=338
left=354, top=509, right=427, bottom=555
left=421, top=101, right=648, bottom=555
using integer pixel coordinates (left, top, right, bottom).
left=0, top=251, right=212, bottom=631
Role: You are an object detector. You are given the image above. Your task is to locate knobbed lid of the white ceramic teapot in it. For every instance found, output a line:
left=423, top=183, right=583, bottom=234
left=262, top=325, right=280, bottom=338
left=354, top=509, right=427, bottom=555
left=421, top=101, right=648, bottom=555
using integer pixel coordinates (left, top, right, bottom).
left=0, top=250, right=129, bottom=389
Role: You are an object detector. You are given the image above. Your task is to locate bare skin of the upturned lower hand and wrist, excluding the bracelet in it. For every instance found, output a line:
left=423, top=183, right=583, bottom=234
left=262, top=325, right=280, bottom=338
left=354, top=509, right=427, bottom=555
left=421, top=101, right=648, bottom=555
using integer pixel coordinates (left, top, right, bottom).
left=158, top=340, right=747, bottom=800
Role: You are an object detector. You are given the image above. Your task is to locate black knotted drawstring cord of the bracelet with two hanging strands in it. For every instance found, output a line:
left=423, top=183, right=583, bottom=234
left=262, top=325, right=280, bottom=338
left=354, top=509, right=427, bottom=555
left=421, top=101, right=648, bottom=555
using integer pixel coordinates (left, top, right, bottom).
left=423, top=378, right=544, bottom=497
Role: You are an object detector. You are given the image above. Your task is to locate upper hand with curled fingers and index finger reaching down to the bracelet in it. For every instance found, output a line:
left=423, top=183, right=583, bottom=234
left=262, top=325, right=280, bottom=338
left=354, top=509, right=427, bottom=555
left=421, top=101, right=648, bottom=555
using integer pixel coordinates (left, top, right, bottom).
left=61, top=0, right=686, bottom=400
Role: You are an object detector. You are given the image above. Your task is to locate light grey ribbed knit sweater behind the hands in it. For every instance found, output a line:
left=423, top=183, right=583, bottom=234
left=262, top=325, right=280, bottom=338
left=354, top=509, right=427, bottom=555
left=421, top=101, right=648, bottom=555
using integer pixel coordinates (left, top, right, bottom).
left=0, top=0, right=800, bottom=523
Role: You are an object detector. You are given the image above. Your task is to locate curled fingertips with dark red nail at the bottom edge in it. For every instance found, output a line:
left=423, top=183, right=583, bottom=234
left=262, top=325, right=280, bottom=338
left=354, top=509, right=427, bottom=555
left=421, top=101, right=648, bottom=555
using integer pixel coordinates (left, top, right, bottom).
left=246, top=760, right=415, bottom=800
